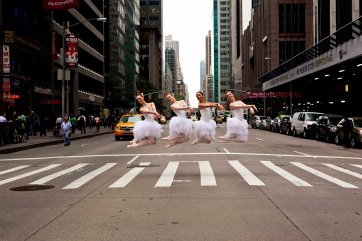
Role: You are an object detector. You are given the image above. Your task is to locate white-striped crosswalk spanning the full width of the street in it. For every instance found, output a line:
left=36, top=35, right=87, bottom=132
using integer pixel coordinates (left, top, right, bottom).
left=0, top=160, right=362, bottom=190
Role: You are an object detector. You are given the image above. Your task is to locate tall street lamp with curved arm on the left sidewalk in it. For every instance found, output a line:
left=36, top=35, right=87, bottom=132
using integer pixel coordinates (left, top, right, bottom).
left=61, top=18, right=107, bottom=116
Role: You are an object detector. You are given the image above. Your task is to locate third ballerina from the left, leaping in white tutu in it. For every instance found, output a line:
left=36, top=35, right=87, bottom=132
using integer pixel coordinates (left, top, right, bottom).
left=192, top=91, right=224, bottom=145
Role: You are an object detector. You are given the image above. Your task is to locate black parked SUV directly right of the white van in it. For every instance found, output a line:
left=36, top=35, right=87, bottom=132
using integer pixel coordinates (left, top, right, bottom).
left=315, top=114, right=342, bottom=142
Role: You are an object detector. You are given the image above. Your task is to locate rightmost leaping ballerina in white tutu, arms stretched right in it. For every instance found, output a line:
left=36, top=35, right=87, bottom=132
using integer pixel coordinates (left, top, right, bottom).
left=219, top=92, right=258, bottom=143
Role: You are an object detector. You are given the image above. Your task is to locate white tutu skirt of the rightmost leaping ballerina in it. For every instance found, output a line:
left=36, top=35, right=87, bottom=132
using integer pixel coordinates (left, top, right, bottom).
left=225, top=118, right=248, bottom=141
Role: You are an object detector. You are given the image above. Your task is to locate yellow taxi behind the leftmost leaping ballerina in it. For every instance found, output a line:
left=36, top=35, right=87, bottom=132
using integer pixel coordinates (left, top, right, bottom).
left=114, top=114, right=142, bottom=141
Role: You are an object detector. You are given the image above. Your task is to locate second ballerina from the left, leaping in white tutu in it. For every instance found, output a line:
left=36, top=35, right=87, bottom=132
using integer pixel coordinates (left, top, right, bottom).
left=162, top=93, right=193, bottom=147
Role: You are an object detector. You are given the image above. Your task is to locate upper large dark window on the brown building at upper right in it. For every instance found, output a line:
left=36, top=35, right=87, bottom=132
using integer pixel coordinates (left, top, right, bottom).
left=279, top=4, right=305, bottom=33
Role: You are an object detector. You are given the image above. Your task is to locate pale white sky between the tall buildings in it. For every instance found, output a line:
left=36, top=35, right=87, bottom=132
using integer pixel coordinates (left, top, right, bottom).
left=162, top=0, right=251, bottom=107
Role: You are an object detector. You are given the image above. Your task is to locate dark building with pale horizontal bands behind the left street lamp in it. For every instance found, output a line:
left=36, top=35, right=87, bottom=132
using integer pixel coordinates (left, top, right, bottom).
left=0, top=0, right=105, bottom=119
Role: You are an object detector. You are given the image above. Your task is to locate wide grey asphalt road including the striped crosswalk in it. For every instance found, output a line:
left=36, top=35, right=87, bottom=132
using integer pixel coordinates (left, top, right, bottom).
left=0, top=124, right=362, bottom=241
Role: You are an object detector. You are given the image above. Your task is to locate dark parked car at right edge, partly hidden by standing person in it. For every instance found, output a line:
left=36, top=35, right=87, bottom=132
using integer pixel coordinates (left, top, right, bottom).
left=334, top=117, right=362, bottom=148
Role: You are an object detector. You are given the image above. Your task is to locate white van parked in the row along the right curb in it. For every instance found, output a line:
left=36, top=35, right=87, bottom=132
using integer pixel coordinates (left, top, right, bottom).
left=291, top=112, right=323, bottom=138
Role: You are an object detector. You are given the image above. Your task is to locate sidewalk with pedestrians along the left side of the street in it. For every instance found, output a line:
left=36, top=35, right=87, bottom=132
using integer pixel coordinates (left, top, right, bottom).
left=0, top=126, right=114, bottom=154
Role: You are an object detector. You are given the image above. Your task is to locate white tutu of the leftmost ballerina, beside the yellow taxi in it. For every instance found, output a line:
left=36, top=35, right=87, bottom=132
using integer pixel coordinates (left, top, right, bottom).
left=133, top=114, right=163, bottom=142
